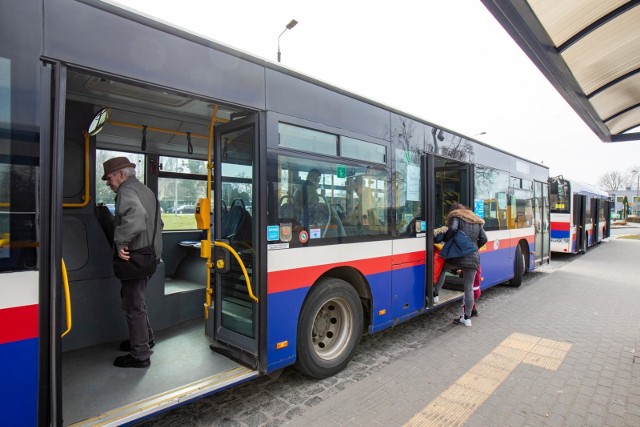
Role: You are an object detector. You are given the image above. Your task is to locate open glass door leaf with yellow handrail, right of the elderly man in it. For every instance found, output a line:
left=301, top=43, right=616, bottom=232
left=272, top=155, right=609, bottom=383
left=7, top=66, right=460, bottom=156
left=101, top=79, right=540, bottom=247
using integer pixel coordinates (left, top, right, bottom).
left=207, top=114, right=261, bottom=369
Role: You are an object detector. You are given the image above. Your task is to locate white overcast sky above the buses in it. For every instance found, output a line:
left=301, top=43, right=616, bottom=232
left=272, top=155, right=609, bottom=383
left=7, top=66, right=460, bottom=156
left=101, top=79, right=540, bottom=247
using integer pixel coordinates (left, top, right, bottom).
left=114, top=0, right=640, bottom=185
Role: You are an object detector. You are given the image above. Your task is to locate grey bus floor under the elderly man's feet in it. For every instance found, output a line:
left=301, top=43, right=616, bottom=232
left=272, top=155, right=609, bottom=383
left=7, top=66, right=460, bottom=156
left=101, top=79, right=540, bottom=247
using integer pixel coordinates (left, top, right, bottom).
left=62, top=318, right=241, bottom=425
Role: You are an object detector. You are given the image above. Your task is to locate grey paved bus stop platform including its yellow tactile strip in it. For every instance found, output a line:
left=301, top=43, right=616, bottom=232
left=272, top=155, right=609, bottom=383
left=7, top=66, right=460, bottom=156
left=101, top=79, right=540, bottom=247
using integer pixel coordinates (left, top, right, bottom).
left=287, top=237, right=640, bottom=427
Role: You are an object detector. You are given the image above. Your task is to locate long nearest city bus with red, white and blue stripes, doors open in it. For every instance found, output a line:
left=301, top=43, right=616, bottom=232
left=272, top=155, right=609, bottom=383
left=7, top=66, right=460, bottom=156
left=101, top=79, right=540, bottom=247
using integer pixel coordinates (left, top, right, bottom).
left=0, top=0, right=549, bottom=426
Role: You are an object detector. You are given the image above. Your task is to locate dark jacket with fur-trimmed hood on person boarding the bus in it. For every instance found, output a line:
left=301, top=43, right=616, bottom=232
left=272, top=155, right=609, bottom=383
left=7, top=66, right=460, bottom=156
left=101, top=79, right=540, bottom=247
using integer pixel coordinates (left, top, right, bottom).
left=444, top=209, right=487, bottom=270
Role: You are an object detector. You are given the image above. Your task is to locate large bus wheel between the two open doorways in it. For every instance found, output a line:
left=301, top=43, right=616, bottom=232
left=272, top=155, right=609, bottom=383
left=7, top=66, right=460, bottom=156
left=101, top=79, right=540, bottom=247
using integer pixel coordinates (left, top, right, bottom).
left=296, top=278, right=363, bottom=379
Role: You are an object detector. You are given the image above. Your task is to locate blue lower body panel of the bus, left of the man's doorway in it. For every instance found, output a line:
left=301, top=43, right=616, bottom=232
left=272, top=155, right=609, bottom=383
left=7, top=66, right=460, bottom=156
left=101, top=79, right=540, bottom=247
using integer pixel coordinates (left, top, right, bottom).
left=0, top=338, right=38, bottom=426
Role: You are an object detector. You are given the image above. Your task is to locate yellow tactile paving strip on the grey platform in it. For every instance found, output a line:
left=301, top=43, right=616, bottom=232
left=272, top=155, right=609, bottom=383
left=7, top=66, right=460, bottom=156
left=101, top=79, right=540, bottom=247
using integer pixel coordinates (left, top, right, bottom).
left=404, top=333, right=571, bottom=427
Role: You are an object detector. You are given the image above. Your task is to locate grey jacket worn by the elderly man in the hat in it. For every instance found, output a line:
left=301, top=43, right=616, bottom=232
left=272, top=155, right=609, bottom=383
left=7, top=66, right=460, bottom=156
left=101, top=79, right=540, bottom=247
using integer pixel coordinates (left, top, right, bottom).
left=113, top=176, right=162, bottom=260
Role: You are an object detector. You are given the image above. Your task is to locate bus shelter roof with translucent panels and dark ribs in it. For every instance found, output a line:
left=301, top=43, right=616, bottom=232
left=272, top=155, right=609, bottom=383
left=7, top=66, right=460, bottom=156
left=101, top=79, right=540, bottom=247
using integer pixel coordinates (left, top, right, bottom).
left=482, top=0, right=640, bottom=142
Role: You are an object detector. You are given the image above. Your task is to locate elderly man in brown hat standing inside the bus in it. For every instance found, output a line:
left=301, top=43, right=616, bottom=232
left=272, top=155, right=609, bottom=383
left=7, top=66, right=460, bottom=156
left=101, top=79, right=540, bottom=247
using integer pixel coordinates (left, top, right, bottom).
left=102, top=157, right=162, bottom=368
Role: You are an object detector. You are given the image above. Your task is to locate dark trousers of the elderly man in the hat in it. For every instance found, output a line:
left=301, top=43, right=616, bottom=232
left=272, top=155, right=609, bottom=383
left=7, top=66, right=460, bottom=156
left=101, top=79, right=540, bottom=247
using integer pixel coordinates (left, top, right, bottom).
left=120, top=277, right=154, bottom=360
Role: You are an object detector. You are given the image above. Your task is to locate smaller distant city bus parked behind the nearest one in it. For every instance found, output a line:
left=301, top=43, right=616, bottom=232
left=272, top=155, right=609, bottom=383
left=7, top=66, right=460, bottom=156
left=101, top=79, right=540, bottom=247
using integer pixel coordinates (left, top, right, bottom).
left=549, top=175, right=611, bottom=254
